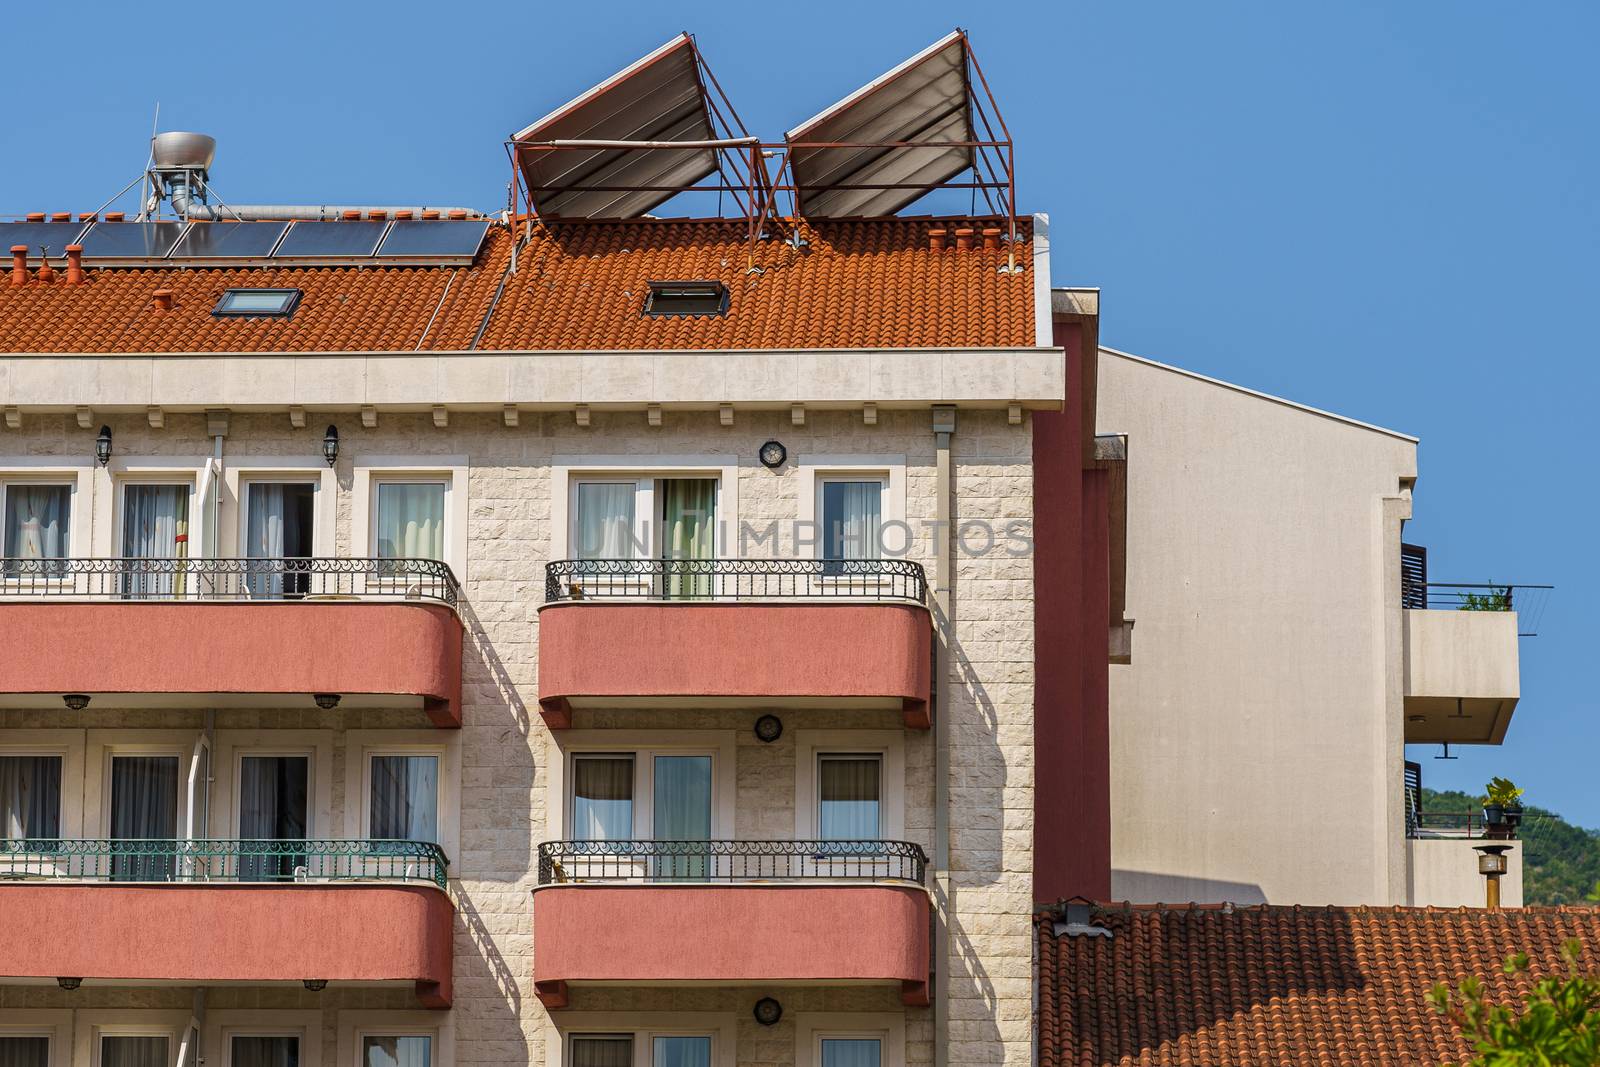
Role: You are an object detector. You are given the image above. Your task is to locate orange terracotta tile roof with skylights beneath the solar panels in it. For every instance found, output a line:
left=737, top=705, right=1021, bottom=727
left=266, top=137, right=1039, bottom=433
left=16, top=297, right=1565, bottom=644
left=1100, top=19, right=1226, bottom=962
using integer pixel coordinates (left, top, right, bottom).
left=0, top=219, right=1034, bottom=352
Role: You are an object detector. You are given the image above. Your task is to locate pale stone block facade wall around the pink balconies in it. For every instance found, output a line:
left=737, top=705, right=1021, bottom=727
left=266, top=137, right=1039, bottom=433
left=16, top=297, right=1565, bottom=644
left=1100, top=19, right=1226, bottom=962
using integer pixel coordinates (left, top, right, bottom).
left=0, top=410, right=1034, bottom=1067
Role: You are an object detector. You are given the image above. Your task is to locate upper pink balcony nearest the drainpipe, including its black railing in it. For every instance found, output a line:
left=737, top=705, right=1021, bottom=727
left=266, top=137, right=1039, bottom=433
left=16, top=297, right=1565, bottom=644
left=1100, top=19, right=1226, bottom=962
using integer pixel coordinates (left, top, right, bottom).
left=539, top=560, right=933, bottom=729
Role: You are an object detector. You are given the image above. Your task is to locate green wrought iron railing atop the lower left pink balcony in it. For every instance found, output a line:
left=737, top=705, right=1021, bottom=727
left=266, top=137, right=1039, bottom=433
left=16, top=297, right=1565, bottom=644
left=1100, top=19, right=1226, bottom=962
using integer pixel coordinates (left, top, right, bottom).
left=0, top=838, right=450, bottom=889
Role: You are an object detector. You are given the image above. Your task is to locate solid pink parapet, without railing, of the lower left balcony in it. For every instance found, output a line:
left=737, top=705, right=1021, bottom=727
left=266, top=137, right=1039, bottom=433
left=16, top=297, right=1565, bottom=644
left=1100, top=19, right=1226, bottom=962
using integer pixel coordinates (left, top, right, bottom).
left=0, top=881, right=454, bottom=1008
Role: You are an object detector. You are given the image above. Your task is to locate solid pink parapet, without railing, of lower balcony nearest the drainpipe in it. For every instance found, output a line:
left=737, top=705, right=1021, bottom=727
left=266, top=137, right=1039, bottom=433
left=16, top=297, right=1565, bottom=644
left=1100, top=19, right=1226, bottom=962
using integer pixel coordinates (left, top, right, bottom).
left=533, top=885, right=928, bottom=1008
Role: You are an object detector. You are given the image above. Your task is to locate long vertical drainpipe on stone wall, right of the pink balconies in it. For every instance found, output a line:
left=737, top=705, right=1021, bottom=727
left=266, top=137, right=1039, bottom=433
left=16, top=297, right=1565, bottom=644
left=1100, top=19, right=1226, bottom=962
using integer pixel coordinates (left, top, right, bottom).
left=933, top=403, right=955, bottom=1067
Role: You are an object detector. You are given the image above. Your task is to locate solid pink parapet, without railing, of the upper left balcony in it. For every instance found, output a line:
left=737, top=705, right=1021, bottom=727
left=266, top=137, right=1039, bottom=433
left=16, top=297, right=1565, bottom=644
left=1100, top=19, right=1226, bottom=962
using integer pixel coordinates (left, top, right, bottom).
left=0, top=600, right=462, bottom=726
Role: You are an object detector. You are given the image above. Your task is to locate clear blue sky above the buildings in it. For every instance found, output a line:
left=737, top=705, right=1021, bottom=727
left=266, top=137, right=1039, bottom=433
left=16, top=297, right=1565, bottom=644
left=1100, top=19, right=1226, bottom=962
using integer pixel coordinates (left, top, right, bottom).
left=0, top=0, right=1600, bottom=827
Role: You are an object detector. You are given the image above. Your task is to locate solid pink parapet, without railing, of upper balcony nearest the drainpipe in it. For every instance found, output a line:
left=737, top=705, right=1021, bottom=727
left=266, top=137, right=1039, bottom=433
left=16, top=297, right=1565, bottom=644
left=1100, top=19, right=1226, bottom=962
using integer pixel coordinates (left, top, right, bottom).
left=539, top=601, right=933, bottom=729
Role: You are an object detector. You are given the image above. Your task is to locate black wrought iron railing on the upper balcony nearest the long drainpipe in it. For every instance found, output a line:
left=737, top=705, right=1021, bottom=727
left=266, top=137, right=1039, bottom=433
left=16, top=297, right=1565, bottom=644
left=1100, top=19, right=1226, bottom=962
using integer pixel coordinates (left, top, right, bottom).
left=544, top=560, right=928, bottom=603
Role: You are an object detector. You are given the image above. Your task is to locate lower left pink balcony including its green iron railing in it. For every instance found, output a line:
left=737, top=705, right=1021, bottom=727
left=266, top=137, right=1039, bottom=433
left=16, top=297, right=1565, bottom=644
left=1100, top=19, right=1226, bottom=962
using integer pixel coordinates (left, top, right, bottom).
left=0, top=840, right=454, bottom=1008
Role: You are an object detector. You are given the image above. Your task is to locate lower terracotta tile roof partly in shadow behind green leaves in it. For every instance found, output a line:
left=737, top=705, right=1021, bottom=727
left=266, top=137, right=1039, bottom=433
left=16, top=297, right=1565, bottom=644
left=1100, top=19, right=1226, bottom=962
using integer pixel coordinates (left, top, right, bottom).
left=1037, top=905, right=1600, bottom=1067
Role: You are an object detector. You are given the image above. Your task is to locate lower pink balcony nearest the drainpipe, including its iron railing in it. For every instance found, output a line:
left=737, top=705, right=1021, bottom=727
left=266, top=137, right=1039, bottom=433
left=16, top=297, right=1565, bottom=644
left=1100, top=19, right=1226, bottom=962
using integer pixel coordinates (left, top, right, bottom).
left=533, top=841, right=930, bottom=1009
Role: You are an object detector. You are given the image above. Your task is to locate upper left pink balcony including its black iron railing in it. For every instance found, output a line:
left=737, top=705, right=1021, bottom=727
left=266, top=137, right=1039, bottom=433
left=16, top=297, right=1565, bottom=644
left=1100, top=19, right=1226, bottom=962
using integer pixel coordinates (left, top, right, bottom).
left=0, top=558, right=462, bottom=726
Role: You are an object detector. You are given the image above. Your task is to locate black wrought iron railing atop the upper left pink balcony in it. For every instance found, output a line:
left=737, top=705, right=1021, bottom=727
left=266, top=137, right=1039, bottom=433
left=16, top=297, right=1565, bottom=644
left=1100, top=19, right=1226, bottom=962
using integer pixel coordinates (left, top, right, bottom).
left=0, top=558, right=461, bottom=606
